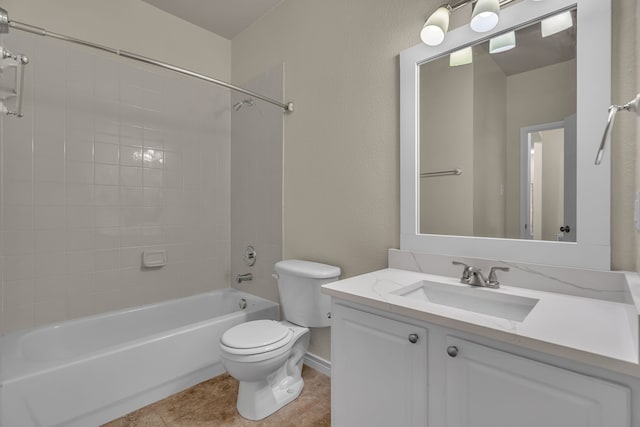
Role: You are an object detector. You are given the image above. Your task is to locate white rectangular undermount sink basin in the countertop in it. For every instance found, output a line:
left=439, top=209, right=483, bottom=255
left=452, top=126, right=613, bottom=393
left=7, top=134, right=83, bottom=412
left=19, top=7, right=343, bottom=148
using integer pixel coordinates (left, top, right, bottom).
left=391, top=280, right=539, bottom=322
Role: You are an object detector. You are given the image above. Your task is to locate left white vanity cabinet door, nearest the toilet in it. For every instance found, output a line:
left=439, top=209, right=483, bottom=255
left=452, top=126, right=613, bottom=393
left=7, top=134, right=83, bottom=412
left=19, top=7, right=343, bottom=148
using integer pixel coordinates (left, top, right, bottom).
left=331, top=305, right=427, bottom=427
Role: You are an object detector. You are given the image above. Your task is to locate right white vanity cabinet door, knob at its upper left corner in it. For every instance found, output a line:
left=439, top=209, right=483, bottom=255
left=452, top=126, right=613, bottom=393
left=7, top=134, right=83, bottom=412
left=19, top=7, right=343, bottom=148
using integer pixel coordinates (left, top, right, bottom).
left=446, top=337, right=631, bottom=427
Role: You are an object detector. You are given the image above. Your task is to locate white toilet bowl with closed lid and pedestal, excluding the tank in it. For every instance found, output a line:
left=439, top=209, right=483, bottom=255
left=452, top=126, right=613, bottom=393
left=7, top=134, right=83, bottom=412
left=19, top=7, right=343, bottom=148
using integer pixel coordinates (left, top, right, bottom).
left=220, top=320, right=309, bottom=421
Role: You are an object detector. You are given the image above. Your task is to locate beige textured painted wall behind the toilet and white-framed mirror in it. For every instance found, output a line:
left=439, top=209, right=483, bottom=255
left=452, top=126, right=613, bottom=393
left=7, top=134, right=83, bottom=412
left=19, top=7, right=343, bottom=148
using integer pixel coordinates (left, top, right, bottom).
left=231, top=0, right=638, bottom=357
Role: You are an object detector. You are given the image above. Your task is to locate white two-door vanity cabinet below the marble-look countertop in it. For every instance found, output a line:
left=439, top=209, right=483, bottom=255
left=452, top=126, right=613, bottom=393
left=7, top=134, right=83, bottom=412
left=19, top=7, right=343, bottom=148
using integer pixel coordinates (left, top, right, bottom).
left=331, top=300, right=631, bottom=427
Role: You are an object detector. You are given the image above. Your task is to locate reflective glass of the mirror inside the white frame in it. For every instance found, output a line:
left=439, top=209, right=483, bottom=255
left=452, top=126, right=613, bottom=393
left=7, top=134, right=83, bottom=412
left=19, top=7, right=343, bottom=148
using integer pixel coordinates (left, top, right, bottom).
left=418, top=11, right=578, bottom=242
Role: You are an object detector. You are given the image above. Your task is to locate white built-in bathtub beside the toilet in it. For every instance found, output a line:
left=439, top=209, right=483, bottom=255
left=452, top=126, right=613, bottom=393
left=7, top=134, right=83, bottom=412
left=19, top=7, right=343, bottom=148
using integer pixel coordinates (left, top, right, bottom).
left=0, top=289, right=278, bottom=427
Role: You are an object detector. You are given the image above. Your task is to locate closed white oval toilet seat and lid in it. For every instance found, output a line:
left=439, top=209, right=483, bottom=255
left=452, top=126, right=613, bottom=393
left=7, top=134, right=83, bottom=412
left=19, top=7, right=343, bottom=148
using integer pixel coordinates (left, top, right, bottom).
left=220, top=320, right=293, bottom=356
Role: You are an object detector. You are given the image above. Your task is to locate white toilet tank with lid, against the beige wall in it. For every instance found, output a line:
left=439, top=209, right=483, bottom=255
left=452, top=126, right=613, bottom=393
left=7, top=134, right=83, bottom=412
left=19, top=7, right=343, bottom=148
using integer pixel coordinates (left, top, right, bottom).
left=274, top=259, right=340, bottom=328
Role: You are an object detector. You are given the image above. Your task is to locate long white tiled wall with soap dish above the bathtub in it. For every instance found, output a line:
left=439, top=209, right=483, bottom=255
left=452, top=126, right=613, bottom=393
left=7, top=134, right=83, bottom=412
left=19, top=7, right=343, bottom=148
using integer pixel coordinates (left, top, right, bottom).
left=0, top=32, right=230, bottom=333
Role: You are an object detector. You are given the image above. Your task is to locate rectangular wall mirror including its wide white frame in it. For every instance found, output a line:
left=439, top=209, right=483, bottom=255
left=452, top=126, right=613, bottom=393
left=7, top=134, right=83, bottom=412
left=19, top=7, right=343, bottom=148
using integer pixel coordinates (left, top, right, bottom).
left=400, top=0, right=611, bottom=269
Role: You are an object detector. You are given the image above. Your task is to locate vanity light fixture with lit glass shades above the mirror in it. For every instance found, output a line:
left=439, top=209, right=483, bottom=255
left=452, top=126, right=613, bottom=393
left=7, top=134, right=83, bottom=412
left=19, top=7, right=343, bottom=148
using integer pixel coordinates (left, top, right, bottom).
left=420, top=0, right=528, bottom=46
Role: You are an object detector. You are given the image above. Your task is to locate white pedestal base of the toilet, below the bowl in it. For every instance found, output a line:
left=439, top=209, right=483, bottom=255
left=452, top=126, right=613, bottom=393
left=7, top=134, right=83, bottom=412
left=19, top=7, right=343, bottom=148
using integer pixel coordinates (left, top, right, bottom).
left=237, top=372, right=304, bottom=421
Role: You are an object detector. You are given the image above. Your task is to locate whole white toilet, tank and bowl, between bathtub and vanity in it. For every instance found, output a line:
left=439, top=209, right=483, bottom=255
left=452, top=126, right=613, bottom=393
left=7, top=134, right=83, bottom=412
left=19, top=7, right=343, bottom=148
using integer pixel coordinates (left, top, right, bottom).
left=220, top=259, right=340, bottom=421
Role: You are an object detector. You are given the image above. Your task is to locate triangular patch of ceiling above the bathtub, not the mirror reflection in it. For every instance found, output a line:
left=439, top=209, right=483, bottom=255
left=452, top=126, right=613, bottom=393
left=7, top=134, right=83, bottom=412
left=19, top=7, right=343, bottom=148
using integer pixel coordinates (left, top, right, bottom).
left=142, top=0, right=282, bottom=40
